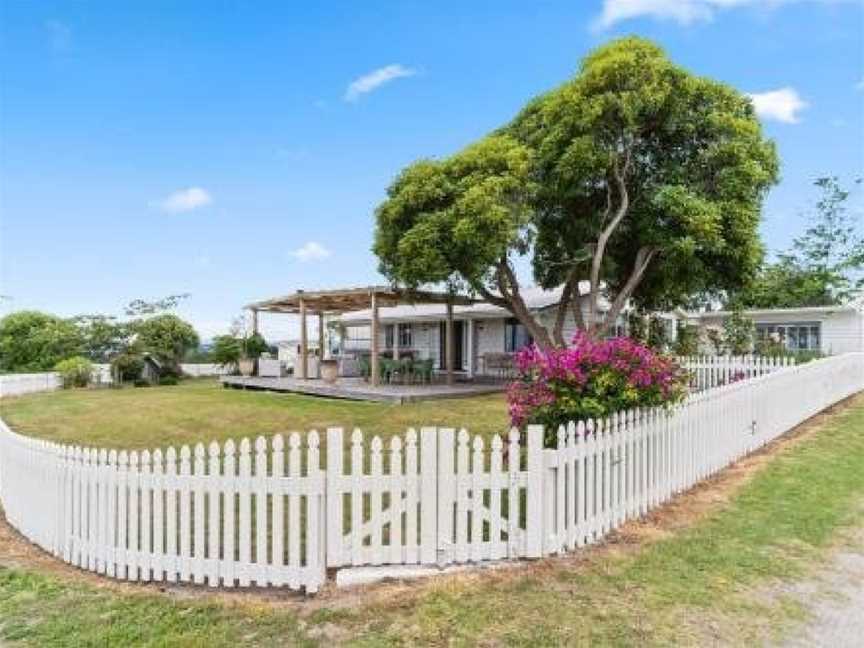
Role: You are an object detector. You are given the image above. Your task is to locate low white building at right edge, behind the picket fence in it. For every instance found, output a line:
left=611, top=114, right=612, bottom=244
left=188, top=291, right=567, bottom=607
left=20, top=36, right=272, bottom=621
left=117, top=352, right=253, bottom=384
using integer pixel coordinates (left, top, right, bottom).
left=687, top=296, right=864, bottom=355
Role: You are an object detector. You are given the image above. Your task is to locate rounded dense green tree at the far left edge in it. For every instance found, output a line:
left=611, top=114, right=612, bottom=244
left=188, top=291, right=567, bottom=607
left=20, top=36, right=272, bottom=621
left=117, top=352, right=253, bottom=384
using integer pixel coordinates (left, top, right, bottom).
left=0, top=311, right=83, bottom=372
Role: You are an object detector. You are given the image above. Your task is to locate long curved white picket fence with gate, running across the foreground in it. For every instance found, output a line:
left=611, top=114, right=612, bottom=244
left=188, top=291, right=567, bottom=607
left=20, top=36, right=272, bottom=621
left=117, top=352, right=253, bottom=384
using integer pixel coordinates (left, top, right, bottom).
left=0, top=353, right=864, bottom=592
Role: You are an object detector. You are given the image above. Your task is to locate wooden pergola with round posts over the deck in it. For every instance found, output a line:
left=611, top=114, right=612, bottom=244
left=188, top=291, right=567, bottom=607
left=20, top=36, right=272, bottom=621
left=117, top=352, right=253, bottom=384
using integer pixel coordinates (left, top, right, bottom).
left=246, top=286, right=478, bottom=385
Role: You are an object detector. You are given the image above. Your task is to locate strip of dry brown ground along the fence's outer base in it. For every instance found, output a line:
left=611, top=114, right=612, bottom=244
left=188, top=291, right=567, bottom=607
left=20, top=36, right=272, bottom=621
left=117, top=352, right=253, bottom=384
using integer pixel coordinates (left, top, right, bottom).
left=0, top=394, right=864, bottom=620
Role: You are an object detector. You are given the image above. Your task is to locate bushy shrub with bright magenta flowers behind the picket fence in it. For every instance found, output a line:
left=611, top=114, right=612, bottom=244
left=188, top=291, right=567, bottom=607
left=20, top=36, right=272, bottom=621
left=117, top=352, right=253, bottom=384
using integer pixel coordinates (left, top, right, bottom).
left=507, top=333, right=688, bottom=446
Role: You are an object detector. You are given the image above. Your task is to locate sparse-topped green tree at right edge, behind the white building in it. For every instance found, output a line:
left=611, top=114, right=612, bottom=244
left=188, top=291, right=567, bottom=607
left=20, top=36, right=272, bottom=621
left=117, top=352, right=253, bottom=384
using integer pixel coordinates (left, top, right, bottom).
left=730, top=176, right=864, bottom=308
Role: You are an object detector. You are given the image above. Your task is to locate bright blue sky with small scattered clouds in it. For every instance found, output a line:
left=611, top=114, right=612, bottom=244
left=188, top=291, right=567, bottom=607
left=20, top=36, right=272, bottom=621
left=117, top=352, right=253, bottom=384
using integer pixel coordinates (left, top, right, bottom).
left=0, top=0, right=864, bottom=337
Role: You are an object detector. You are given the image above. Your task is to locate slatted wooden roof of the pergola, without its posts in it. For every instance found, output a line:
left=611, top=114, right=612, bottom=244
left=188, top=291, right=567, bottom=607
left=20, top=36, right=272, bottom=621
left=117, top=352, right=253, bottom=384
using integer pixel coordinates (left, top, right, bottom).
left=246, top=286, right=478, bottom=313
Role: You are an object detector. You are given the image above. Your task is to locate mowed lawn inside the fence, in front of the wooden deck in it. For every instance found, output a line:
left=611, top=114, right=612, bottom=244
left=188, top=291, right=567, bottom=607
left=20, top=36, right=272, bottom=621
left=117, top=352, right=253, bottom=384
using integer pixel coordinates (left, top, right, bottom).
left=0, top=380, right=508, bottom=450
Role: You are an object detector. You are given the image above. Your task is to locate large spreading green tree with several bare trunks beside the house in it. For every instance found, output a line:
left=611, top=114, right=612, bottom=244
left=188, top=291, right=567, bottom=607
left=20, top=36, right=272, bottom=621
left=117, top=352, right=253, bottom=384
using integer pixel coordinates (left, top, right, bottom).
left=374, top=38, right=778, bottom=346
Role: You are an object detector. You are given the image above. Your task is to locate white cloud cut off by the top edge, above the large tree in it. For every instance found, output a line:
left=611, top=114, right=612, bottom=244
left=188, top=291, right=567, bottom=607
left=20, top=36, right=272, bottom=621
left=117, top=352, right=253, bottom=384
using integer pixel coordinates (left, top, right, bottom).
left=593, top=0, right=841, bottom=29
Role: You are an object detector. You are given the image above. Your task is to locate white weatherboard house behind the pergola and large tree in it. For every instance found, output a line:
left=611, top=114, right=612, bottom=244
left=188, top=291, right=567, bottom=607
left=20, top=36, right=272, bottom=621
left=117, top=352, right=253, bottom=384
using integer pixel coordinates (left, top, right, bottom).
left=338, top=287, right=623, bottom=377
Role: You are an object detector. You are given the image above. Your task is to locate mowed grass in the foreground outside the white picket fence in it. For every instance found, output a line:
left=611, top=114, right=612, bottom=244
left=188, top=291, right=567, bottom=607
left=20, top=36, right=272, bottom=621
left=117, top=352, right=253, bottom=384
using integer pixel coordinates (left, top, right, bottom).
left=0, top=396, right=864, bottom=646
